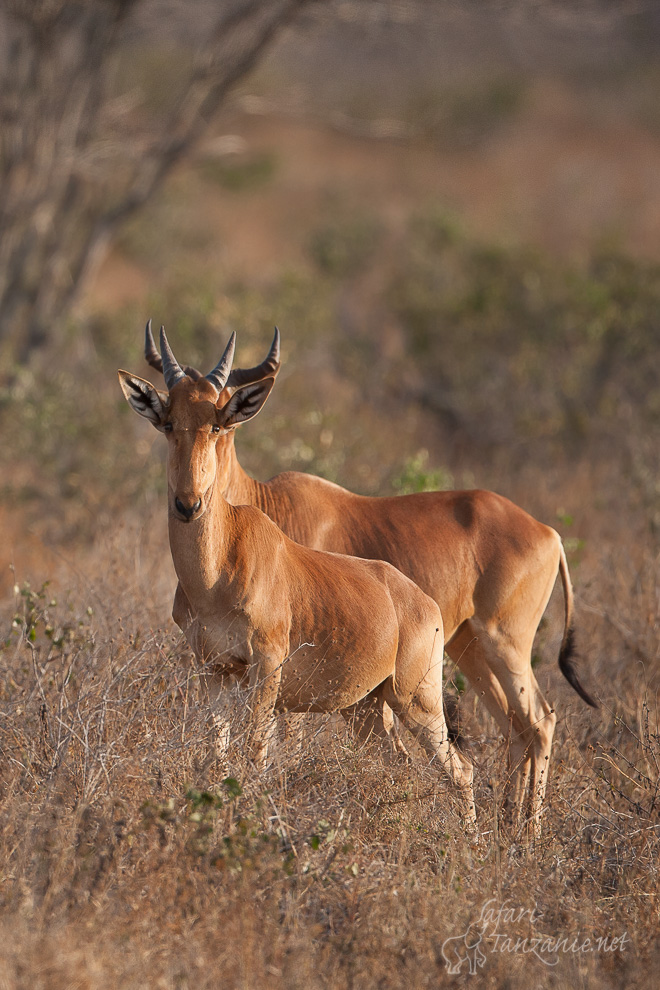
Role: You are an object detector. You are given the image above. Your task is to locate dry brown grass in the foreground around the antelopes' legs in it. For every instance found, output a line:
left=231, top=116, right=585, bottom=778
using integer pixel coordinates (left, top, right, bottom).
left=0, top=526, right=660, bottom=990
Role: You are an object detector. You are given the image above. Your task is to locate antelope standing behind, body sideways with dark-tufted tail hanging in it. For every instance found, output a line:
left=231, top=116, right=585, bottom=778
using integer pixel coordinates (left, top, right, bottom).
left=145, top=323, right=596, bottom=830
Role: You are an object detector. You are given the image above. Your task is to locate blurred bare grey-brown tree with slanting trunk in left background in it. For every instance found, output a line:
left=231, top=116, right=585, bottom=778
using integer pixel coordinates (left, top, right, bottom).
left=0, top=0, right=306, bottom=369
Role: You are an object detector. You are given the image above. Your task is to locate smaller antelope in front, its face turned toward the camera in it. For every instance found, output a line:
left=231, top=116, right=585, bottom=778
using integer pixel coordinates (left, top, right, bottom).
left=119, top=329, right=474, bottom=821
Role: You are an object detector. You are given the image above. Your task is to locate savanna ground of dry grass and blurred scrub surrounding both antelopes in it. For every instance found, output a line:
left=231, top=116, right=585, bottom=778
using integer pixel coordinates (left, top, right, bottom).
left=0, top=33, right=660, bottom=990
